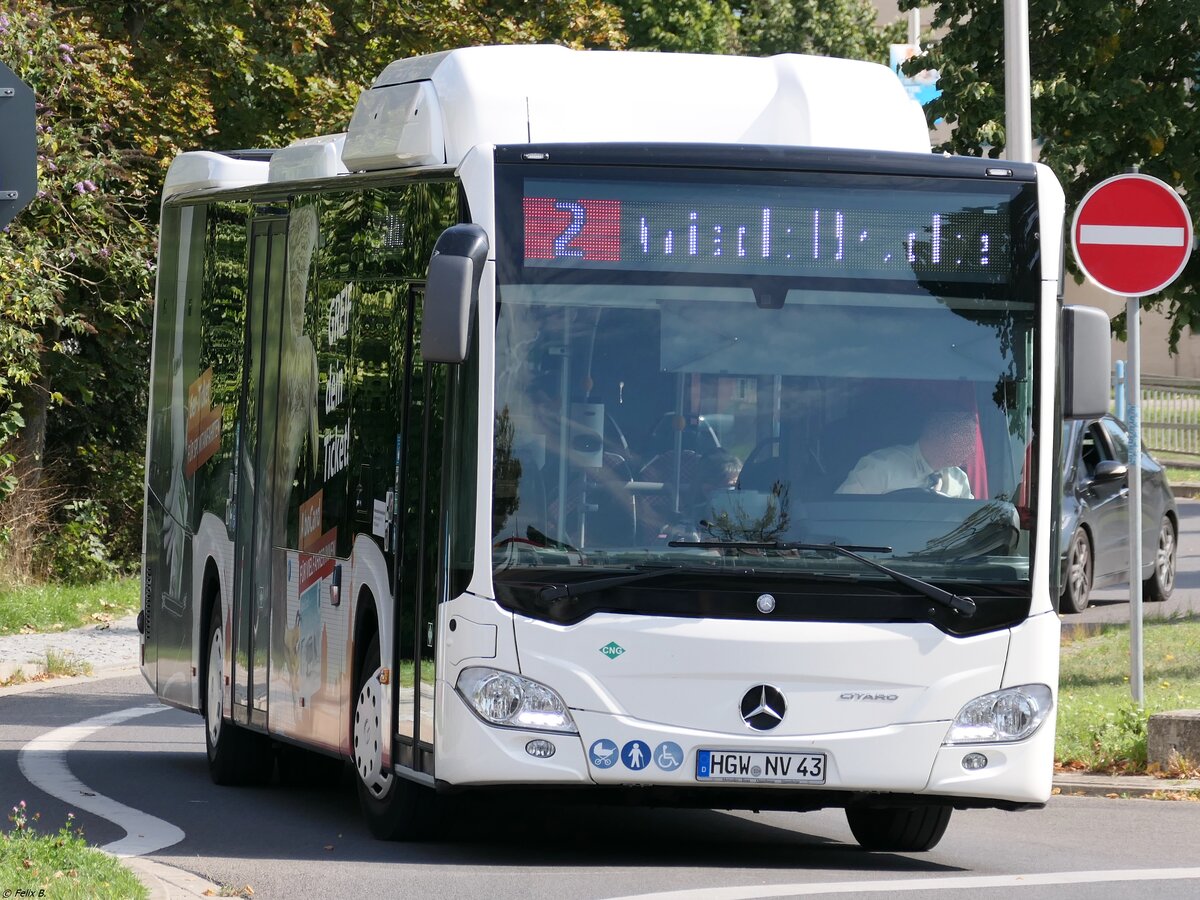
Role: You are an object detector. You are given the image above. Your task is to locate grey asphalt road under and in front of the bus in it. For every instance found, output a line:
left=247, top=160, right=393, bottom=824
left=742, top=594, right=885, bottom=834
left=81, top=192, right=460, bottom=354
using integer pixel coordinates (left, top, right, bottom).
left=7, top=676, right=1200, bottom=900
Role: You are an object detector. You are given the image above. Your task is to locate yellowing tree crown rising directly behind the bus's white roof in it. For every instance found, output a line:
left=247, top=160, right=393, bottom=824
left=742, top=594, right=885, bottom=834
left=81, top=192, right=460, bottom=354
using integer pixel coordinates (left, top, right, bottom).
left=88, top=0, right=624, bottom=149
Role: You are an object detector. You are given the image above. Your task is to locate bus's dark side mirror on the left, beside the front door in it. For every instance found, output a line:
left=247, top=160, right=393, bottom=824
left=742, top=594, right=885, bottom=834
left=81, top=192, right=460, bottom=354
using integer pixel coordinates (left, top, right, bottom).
left=421, top=224, right=487, bottom=364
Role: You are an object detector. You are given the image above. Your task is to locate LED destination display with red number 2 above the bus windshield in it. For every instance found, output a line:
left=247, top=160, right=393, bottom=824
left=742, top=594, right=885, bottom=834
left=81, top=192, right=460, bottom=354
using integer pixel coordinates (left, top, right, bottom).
left=522, top=179, right=1012, bottom=283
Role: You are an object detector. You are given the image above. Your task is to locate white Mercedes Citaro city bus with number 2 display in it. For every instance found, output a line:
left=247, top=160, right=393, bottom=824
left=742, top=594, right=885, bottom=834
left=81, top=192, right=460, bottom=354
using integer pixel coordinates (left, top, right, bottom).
left=142, top=47, right=1108, bottom=851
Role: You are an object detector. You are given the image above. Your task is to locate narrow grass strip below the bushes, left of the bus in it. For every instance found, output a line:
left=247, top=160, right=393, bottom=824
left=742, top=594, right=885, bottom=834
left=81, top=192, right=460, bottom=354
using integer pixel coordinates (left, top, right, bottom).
left=0, top=578, right=140, bottom=635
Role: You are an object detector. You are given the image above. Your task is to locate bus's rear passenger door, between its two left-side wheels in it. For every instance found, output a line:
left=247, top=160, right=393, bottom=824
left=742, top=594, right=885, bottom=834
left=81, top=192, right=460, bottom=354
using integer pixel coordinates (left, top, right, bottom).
left=232, top=217, right=287, bottom=728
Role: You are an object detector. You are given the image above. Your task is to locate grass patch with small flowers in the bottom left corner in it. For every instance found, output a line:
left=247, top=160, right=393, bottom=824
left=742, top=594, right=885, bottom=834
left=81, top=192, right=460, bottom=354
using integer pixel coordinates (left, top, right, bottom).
left=0, top=800, right=149, bottom=900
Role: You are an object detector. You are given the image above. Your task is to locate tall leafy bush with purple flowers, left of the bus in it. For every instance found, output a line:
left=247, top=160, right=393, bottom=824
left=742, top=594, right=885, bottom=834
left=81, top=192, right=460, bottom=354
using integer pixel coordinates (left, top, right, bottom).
left=0, top=0, right=174, bottom=575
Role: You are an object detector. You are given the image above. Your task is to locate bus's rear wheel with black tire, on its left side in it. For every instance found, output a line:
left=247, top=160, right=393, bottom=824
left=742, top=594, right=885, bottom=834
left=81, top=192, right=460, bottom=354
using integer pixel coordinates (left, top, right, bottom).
left=200, top=599, right=275, bottom=785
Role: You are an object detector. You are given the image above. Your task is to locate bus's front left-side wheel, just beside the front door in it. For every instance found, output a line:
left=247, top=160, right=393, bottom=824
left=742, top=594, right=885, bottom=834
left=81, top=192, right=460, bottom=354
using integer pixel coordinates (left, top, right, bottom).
left=350, top=635, right=437, bottom=841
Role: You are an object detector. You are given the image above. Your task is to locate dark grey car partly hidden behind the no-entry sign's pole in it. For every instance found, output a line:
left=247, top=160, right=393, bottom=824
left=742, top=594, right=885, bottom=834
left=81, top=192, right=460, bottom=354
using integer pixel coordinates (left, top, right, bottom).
left=1060, top=415, right=1180, bottom=613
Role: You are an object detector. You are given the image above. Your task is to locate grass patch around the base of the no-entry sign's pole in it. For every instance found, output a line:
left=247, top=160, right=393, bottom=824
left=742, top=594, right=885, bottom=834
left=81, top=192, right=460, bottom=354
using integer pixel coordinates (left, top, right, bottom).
left=1056, top=617, right=1200, bottom=773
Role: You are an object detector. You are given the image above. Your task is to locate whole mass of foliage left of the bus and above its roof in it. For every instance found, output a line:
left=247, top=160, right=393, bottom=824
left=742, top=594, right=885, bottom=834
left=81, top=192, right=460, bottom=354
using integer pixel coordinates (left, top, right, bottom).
left=0, top=0, right=624, bottom=580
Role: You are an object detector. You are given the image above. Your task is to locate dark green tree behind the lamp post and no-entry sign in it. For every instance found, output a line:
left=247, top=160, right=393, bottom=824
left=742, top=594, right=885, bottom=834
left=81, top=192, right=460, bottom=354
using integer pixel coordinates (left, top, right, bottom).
left=900, top=0, right=1200, bottom=348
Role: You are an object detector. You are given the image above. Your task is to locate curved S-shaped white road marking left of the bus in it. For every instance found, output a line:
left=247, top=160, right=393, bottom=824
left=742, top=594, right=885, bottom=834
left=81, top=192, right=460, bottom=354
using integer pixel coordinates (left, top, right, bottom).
left=17, top=706, right=186, bottom=857
